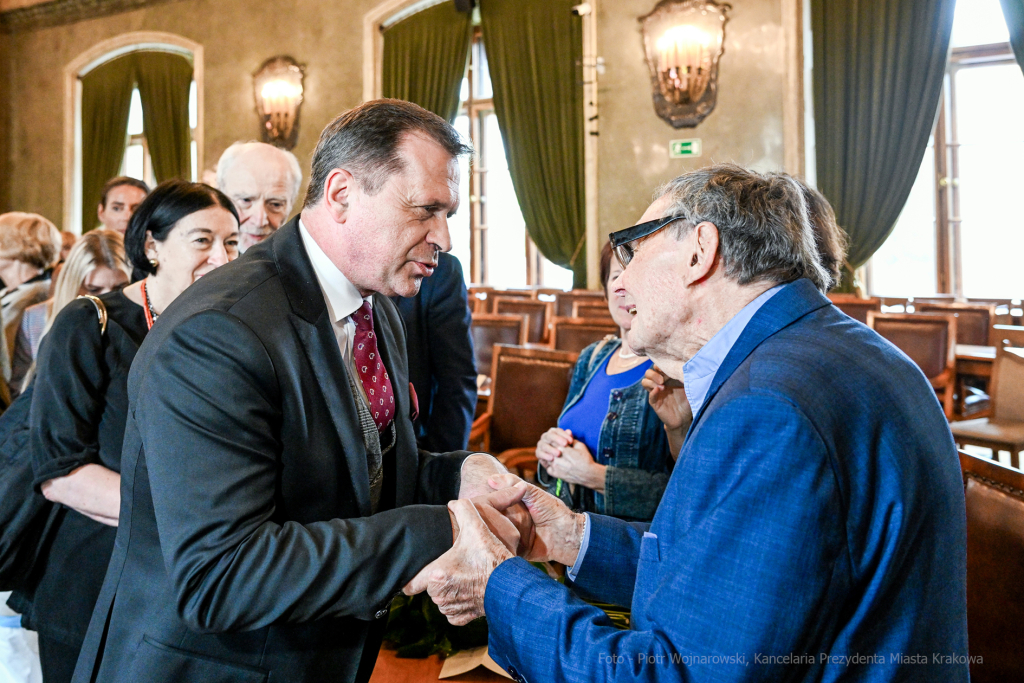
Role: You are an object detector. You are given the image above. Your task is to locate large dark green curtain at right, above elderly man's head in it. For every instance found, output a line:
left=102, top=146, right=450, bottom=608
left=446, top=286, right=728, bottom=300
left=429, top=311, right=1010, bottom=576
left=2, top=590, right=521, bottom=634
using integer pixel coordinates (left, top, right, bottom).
left=811, top=0, right=955, bottom=287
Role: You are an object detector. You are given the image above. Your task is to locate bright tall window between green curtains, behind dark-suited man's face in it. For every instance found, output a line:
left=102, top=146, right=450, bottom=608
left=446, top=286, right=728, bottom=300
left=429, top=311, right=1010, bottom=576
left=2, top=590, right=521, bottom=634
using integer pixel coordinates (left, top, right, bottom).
left=449, top=31, right=572, bottom=289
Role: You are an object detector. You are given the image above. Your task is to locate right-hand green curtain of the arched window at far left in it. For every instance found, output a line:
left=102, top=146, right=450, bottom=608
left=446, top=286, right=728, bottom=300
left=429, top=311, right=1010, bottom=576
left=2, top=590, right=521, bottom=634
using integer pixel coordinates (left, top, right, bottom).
left=131, top=52, right=193, bottom=182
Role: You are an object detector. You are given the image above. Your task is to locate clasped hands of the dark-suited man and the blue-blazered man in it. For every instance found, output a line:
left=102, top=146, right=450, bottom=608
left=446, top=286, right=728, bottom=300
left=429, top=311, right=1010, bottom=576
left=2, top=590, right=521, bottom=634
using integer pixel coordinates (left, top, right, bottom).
left=402, top=473, right=584, bottom=626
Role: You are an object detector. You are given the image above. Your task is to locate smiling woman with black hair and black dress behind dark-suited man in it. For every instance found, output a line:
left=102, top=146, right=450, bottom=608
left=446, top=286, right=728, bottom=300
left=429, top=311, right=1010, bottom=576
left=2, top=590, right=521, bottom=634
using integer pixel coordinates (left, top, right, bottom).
left=19, top=180, right=239, bottom=683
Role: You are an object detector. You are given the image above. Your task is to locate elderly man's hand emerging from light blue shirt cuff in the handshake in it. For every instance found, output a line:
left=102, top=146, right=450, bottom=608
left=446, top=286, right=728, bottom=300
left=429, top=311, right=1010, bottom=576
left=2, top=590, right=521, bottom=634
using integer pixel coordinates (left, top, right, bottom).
left=488, top=474, right=584, bottom=566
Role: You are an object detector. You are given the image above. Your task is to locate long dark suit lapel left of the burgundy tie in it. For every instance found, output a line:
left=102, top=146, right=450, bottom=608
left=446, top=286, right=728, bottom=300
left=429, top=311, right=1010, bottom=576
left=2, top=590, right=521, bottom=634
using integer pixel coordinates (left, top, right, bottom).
left=271, top=217, right=371, bottom=516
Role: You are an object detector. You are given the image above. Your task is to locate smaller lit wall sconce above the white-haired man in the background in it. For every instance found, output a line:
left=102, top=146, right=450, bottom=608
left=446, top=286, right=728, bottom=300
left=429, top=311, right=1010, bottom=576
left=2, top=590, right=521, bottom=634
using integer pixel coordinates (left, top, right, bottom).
left=253, top=56, right=304, bottom=150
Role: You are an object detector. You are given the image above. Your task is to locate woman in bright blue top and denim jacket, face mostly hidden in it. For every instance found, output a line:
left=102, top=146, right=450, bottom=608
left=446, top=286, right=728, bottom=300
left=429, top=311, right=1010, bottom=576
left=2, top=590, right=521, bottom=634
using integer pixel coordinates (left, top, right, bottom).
left=537, top=244, right=688, bottom=520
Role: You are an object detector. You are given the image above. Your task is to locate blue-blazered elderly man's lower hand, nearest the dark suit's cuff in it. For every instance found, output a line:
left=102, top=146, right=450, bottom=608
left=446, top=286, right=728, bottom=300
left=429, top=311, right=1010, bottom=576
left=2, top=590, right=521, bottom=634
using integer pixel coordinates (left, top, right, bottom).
left=402, top=483, right=525, bottom=626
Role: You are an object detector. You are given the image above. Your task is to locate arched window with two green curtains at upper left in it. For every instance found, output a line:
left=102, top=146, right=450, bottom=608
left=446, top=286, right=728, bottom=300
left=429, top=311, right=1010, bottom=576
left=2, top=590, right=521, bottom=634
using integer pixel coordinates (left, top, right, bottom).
left=65, top=32, right=203, bottom=232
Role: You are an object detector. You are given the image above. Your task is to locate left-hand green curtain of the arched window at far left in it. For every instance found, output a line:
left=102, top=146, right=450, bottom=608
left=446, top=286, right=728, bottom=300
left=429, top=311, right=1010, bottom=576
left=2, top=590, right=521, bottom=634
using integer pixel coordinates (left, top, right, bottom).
left=82, top=54, right=135, bottom=232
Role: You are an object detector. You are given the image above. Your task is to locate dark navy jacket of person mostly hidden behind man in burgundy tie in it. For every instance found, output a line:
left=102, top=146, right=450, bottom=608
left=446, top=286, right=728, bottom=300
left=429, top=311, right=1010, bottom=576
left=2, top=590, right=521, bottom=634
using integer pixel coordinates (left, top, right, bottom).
left=392, top=254, right=476, bottom=452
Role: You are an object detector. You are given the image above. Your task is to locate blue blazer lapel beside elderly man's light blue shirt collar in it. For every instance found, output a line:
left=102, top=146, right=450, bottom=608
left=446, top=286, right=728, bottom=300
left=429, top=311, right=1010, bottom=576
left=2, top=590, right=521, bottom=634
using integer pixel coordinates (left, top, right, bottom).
left=687, top=279, right=830, bottom=430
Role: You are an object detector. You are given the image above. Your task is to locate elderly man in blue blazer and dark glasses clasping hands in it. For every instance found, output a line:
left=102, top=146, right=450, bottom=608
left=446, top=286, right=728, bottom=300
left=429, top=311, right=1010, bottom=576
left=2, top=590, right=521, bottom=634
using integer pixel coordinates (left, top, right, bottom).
left=406, top=166, right=968, bottom=682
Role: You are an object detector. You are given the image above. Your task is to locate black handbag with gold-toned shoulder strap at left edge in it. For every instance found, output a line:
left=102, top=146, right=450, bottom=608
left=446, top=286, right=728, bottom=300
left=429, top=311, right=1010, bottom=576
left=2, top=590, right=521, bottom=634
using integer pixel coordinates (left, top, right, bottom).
left=0, top=296, right=106, bottom=591
